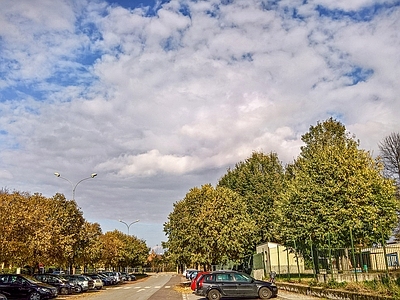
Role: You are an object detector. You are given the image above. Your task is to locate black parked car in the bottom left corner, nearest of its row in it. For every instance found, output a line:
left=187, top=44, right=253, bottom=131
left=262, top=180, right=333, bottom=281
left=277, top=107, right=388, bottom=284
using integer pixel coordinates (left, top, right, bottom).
left=0, top=274, right=58, bottom=300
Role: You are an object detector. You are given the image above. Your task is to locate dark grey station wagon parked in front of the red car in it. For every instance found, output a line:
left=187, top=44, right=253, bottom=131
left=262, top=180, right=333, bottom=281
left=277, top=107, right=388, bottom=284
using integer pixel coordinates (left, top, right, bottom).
left=194, top=271, right=278, bottom=300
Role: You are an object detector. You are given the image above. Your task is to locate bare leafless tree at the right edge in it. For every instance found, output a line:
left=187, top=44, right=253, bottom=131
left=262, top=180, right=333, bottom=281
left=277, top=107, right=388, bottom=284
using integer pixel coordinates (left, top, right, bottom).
left=379, top=132, right=400, bottom=186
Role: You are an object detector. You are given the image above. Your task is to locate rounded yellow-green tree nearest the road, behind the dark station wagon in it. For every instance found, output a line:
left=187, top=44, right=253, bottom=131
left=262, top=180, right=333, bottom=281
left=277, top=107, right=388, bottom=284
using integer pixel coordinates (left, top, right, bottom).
left=163, top=184, right=254, bottom=268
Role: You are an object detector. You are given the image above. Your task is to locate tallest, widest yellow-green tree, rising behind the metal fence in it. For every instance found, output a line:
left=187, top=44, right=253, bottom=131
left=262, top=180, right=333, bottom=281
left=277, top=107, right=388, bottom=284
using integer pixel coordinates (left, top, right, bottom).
left=281, top=118, right=398, bottom=252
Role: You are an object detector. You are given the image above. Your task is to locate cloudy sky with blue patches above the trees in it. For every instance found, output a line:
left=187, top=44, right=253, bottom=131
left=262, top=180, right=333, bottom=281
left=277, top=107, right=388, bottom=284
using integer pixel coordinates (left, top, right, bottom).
left=0, top=0, right=400, bottom=248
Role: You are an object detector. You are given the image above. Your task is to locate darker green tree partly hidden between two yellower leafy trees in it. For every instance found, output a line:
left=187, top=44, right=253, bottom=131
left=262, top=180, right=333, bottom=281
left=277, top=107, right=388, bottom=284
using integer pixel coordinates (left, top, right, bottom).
left=218, top=152, right=284, bottom=250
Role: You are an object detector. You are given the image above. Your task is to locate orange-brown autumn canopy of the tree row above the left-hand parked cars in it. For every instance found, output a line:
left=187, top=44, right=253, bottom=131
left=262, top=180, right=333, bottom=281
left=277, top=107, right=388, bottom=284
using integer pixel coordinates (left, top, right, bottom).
left=0, top=189, right=150, bottom=268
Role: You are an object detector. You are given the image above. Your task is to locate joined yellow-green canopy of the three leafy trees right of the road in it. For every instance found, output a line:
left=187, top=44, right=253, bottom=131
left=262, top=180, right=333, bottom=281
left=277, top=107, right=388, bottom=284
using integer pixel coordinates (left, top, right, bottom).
left=164, top=118, right=399, bottom=265
